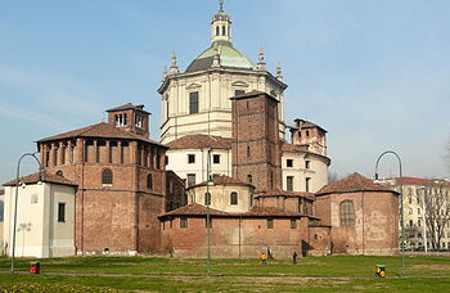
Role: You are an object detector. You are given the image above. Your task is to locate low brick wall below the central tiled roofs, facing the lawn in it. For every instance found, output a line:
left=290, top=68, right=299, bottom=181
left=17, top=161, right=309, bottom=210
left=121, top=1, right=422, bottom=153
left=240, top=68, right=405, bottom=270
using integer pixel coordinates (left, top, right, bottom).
left=162, top=217, right=308, bottom=258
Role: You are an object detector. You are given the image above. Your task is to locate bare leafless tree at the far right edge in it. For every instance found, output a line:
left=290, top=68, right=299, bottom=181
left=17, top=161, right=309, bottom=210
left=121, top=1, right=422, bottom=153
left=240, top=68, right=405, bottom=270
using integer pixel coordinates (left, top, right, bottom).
left=422, top=180, right=450, bottom=250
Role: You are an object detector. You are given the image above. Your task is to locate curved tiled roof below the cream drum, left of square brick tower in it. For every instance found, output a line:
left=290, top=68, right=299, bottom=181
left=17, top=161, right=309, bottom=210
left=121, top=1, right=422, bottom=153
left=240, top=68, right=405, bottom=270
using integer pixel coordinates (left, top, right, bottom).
left=167, top=134, right=233, bottom=149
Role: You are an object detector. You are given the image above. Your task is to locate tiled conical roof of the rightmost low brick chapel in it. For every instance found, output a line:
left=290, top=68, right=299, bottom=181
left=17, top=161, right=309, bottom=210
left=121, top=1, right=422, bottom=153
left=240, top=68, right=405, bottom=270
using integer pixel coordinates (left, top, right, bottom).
left=316, top=173, right=396, bottom=195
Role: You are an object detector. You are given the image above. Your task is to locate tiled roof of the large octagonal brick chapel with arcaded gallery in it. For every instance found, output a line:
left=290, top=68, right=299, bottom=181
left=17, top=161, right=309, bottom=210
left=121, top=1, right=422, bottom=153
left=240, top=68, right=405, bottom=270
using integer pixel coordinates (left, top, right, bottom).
left=38, top=122, right=166, bottom=147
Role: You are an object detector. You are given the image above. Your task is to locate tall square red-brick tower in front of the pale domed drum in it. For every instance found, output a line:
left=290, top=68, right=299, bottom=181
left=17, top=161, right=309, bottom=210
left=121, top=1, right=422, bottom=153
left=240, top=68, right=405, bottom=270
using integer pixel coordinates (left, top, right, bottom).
left=231, top=91, right=281, bottom=192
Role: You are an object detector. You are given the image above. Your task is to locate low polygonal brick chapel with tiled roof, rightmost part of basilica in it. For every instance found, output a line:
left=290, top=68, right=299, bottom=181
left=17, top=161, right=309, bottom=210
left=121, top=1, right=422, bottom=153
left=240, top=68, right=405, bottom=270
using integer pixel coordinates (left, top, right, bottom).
left=315, top=173, right=399, bottom=254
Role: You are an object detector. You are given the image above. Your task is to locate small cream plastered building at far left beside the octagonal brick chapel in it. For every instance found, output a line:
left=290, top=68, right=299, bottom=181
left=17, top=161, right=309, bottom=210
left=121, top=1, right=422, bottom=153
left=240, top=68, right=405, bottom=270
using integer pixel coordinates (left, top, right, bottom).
left=4, top=173, right=76, bottom=258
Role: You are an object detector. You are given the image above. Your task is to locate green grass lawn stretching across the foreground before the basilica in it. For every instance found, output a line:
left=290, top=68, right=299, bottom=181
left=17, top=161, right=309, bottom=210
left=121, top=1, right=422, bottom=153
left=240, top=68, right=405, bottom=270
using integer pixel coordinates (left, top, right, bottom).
left=0, top=256, right=450, bottom=293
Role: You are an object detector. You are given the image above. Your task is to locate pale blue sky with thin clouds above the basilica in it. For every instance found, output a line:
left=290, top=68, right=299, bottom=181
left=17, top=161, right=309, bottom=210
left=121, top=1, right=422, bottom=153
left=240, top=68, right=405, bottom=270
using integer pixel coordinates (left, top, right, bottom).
left=0, top=0, right=450, bottom=182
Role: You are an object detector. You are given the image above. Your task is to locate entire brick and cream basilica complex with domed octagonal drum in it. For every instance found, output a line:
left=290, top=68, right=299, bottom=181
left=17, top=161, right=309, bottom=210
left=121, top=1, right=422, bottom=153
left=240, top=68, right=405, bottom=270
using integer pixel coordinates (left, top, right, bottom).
left=4, top=1, right=398, bottom=258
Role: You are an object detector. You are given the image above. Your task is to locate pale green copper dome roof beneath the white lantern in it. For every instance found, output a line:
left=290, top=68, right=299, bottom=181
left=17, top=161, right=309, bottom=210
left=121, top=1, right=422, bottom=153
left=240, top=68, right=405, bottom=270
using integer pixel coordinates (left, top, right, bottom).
left=186, top=41, right=255, bottom=72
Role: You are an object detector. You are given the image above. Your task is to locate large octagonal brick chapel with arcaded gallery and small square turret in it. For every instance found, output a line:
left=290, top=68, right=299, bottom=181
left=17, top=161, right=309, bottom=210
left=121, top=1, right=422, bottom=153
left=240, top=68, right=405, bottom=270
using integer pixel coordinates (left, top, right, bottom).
left=38, top=105, right=184, bottom=254
